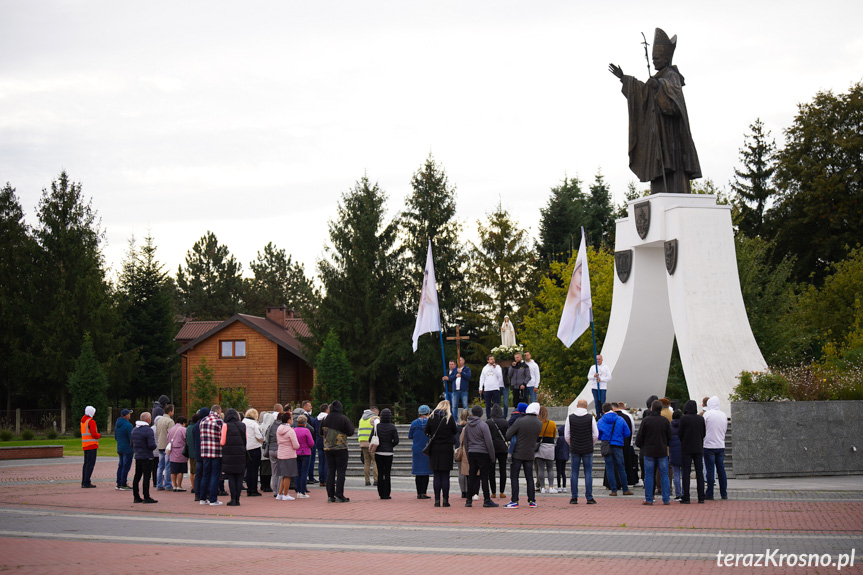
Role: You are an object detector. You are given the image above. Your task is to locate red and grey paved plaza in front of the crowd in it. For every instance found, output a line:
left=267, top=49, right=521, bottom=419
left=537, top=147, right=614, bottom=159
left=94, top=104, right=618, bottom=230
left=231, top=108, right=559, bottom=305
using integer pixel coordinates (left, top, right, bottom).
left=0, top=453, right=863, bottom=575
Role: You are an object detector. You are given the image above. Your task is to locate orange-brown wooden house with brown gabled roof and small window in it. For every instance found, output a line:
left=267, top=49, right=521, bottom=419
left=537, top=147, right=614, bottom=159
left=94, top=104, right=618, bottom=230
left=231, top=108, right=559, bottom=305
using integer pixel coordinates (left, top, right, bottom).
left=174, top=306, right=314, bottom=411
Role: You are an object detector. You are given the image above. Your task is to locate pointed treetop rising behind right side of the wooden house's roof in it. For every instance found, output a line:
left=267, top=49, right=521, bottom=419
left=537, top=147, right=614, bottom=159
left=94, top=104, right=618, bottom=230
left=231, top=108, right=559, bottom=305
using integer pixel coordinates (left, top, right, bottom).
left=245, top=242, right=317, bottom=315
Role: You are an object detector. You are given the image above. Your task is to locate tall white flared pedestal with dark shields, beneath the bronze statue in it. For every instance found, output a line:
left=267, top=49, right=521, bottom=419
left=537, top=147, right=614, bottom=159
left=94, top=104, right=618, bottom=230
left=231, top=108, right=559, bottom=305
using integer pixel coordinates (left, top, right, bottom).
left=572, top=194, right=767, bottom=414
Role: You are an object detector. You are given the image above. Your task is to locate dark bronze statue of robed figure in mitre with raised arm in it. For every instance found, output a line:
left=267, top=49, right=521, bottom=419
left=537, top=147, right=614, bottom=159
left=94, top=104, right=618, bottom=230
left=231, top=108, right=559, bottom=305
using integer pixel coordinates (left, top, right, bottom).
left=608, top=28, right=701, bottom=194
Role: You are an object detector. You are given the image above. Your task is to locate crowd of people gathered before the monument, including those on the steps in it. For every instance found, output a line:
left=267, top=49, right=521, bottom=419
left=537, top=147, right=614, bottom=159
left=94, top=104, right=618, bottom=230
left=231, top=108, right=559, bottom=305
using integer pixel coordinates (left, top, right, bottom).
left=81, top=354, right=728, bottom=509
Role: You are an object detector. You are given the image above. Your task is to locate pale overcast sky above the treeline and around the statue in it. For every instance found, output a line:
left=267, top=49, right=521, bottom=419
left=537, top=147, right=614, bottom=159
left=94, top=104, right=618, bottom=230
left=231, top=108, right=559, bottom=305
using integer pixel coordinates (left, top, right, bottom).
left=0, top=0, right=863, bottom=284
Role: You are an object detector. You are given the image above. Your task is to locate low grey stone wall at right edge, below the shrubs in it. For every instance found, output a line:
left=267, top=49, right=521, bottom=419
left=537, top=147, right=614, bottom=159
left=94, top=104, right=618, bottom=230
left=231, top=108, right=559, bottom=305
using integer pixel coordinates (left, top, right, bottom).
left=731, top=401, right=863, bottom=479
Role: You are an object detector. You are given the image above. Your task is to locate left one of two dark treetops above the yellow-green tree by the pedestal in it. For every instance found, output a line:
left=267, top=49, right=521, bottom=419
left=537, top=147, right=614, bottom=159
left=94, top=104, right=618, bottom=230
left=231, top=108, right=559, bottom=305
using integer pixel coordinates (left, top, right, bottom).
left=536, top=176, right=587, bottom=265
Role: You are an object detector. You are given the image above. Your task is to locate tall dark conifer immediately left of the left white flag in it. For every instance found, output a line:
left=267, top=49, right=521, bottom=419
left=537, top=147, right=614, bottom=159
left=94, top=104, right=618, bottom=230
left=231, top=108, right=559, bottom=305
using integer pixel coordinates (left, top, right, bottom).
left=308, top=176, right=406, bottom=403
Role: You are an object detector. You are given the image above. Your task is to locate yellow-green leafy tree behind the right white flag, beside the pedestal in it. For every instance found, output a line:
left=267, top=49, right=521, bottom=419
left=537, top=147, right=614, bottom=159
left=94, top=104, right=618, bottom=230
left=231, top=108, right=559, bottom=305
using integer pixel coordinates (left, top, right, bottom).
left=521, top=246, right=614, bottom=402
